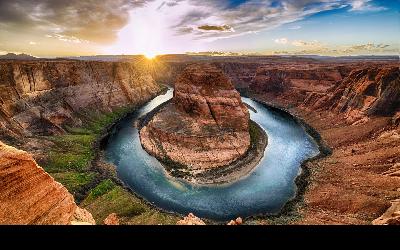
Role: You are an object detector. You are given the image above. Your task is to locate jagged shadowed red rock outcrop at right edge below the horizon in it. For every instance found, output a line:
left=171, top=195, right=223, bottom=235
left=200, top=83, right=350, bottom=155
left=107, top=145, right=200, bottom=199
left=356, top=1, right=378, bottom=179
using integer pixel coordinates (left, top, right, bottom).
left=304, top=67, right=400, bottom=122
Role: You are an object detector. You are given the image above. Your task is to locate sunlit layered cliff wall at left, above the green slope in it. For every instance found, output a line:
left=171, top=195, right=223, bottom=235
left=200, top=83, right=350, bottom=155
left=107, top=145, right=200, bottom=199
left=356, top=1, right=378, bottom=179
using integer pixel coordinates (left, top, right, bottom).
left=0, top=60, right=160, bottom=140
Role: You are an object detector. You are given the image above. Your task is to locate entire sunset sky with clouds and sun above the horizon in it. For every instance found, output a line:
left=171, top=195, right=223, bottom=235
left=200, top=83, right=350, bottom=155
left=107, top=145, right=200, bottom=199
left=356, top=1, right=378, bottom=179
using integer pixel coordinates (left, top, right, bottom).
left=0, top=0, right=400, bottom=57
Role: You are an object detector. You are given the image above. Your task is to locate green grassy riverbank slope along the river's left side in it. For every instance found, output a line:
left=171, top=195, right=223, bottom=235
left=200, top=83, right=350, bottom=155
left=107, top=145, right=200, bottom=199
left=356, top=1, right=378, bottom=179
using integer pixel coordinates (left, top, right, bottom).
left=40, top=88, right=180, bottom=224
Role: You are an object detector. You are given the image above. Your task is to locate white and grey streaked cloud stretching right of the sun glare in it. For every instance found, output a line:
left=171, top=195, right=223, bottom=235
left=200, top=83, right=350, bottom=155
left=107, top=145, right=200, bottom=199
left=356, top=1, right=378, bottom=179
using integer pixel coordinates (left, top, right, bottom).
left=174, top=0, right=362, bottom=40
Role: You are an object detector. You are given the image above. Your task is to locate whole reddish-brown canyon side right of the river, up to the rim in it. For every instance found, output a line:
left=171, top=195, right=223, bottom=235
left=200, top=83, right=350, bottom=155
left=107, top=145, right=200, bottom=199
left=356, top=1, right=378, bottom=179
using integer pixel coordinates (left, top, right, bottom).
left=245, top=62, right=400, bottom=224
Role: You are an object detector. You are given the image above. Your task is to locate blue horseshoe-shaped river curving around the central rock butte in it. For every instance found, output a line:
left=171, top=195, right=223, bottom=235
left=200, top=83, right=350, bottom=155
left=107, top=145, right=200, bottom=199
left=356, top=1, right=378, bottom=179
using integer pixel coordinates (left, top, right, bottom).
left=106, top=90, right=318, bottom=220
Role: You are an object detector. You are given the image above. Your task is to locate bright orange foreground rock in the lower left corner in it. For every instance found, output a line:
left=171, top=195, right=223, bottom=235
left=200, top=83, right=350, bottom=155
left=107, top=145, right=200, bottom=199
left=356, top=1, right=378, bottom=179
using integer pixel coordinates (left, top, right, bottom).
left=0, top=142, right=95, bottom=225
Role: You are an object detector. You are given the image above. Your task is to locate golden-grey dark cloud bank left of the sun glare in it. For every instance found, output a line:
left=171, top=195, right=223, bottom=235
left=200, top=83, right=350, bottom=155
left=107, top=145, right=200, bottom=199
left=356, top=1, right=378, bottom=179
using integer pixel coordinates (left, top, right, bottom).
left=0, top=0, right=152, bottom=43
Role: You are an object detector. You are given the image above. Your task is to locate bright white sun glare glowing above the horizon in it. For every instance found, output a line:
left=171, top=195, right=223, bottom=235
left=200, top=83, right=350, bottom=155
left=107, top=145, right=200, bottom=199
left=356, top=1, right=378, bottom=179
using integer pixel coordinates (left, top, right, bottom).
left=104, top=0, right=202, bottom=55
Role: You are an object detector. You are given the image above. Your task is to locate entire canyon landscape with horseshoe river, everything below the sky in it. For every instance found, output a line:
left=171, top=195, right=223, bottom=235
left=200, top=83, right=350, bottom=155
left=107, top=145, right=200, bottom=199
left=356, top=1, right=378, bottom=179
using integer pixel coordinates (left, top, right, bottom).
left=0, top=55, right=400, bottom=225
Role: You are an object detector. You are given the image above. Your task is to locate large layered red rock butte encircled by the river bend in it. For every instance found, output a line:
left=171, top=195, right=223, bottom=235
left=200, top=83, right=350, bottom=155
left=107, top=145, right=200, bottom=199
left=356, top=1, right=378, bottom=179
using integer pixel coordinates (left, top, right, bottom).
left=140, top=64, right=250, bottom=170
